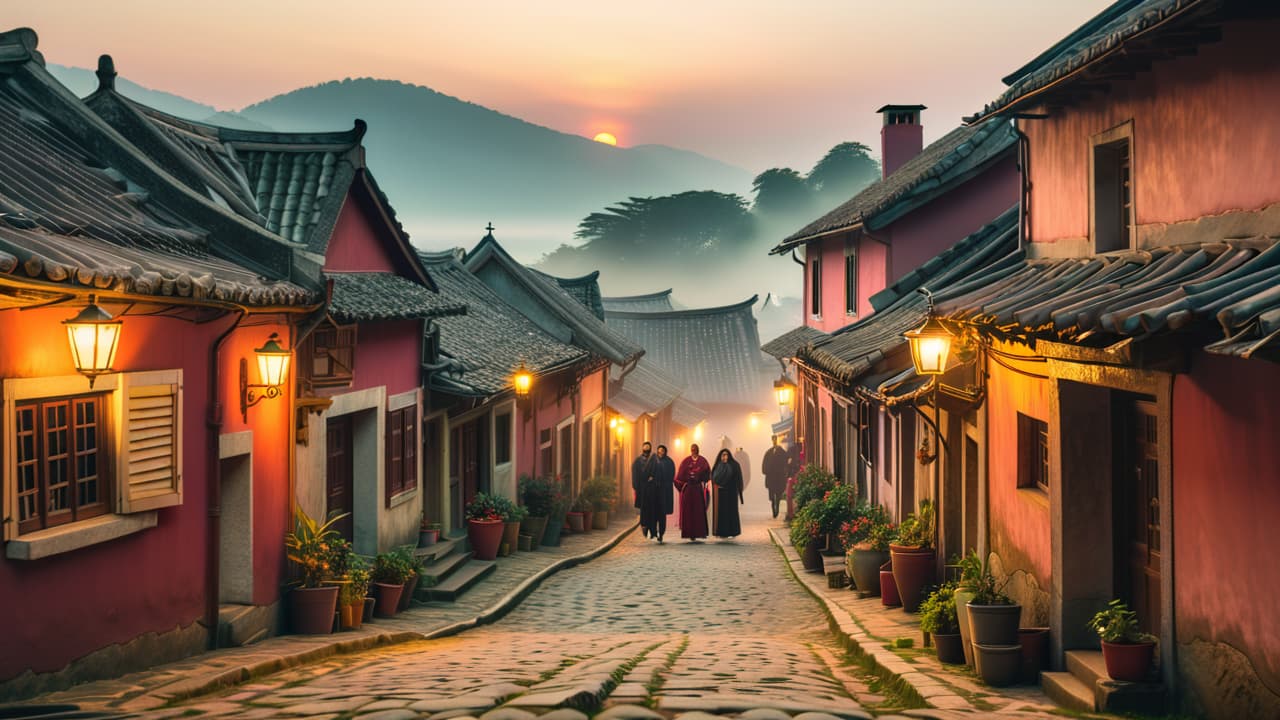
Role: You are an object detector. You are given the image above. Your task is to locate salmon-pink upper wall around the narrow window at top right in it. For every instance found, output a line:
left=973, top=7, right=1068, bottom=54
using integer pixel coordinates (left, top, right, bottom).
left=1020, top=19, right=1280, bottom=242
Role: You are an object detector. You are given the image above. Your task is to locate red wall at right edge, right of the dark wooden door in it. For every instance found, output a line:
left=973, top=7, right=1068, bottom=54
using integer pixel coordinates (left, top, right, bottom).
left=1172, top=352, right=1280, bottom=688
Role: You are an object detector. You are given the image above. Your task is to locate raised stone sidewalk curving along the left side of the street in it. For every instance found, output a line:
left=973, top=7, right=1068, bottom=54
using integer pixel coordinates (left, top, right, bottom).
left=29, top=519, right=635, bottom=712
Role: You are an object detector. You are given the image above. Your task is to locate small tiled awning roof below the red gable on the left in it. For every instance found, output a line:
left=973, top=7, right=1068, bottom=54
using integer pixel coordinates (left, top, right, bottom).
left=325, top=273, right=466, bottom=323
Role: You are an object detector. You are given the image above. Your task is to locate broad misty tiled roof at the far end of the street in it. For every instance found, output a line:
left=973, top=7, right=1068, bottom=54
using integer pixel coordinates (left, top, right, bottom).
left=604, top=296, right=769, bottom=406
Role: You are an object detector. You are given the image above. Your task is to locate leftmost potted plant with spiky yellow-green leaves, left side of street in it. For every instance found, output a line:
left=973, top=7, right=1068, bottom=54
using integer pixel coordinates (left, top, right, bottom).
left=284, top=507, right=346, bottom=634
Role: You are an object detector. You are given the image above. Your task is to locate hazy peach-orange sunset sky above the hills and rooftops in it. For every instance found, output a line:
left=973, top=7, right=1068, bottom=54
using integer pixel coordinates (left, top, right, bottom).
left=0, top=0, right=1108, bottom=172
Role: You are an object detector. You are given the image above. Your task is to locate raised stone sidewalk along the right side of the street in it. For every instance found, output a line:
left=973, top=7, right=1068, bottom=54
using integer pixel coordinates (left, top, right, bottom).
left=771, top=528, right=1106, bottom=720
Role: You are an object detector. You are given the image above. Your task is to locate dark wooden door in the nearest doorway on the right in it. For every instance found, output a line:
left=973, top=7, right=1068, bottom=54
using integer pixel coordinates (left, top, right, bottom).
left=1115, top=400, right=1161, bottom=635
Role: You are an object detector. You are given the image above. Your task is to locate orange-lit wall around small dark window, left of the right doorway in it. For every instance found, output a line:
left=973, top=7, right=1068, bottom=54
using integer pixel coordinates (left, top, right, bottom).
left=987, top=347, right=1053, bottom=588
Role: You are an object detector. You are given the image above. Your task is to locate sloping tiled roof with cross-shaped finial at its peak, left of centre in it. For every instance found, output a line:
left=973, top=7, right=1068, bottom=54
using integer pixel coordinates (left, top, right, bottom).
left=465, top=233, right=644, bottom=365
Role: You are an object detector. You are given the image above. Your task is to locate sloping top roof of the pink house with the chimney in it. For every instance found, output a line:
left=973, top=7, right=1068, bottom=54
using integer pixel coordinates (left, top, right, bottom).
left=769, top=118, right=1018, bottom=255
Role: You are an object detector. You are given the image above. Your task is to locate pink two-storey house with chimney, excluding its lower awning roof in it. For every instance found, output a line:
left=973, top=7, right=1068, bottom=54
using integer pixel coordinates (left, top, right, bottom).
left=764, top=105, right=1019, bottom=515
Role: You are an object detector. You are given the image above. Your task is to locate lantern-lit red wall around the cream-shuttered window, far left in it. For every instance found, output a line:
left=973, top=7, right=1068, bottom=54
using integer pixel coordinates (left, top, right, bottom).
left=0, top=306, right=292, bottom=679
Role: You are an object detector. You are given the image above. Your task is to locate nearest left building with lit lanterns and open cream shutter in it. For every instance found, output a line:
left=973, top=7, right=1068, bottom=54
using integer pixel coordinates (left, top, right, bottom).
left=0, top=29, right=324, bottom=697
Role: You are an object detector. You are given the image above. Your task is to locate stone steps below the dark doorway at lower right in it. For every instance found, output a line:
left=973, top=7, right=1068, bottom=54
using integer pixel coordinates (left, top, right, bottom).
left=1041, top=650, right=1165, bottom=715
